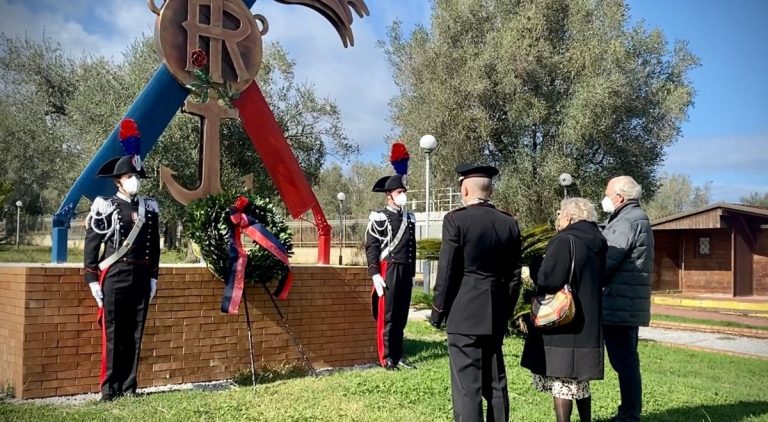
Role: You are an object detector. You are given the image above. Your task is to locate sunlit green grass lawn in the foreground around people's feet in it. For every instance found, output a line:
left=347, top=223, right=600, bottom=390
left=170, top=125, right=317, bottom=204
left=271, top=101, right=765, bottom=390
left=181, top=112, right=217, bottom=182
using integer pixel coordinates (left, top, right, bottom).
left=0, top=322, right=768, bottom=422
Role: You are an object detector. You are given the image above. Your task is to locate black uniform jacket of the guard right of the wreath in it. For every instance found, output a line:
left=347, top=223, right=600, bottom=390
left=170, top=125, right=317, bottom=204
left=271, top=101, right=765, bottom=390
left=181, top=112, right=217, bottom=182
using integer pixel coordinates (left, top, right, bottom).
left=365, top=208, right=416, bottom=276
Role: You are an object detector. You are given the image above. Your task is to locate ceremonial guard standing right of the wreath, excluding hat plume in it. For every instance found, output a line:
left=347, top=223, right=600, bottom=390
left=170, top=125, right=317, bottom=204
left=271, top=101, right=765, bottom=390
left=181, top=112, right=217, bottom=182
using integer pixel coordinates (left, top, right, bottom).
left=365, top=174, right=416, bottom=370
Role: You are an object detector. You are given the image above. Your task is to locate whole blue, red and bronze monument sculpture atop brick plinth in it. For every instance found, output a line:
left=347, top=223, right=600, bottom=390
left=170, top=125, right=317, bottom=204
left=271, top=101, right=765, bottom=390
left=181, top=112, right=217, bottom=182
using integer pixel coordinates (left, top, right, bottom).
left=51, top=0, right=369, bottom=264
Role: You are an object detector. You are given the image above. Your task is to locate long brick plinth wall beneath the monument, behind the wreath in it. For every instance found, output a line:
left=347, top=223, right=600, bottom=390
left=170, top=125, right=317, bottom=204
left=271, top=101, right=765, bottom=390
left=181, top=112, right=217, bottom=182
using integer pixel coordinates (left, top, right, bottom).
left=0, top=264, right=376, bottom=398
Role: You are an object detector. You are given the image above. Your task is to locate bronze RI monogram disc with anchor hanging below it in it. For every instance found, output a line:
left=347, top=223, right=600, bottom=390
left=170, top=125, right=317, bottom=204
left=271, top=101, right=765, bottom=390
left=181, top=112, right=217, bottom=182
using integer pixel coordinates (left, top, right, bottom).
left=149, top=0, right=268, bottom=205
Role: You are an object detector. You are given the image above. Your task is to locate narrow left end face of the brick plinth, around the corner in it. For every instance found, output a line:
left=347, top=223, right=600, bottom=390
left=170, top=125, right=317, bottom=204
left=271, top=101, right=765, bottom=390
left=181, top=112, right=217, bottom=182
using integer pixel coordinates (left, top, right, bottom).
left=0, top=266, right=26, bottom=393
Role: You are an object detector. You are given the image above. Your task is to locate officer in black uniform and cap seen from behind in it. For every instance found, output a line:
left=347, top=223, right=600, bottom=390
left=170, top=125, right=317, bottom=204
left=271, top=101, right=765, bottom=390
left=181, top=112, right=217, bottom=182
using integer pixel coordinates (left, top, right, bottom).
left=430, top=164, right=521, bottom=421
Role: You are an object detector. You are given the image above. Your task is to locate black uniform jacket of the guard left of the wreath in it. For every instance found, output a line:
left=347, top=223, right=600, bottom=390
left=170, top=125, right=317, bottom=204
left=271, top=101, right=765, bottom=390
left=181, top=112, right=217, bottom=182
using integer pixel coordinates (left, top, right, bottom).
left=84, top=196, right=160, bottom=283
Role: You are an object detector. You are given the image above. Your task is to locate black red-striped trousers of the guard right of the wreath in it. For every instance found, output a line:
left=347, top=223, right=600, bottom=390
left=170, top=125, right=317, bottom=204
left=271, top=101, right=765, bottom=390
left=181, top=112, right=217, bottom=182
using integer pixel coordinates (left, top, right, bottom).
left=372, top=262, right=413, bottom=366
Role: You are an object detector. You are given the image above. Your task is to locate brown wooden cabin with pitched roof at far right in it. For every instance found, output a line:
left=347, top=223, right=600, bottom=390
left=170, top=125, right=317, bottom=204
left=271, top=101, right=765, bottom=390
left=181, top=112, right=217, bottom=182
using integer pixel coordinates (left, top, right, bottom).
left=652, top=202, right=768, bottom=297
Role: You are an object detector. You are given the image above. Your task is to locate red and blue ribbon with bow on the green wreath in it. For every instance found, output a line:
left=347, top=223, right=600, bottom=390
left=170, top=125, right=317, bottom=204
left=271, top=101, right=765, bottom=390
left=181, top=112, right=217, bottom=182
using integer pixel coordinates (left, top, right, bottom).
left=221, top=196, right=293, bottom=315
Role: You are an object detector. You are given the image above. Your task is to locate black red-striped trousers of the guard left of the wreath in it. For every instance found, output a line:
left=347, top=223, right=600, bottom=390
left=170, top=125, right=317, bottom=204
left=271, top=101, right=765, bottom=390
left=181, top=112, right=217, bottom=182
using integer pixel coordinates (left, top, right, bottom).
left=101, top=262, right=150, bottom=399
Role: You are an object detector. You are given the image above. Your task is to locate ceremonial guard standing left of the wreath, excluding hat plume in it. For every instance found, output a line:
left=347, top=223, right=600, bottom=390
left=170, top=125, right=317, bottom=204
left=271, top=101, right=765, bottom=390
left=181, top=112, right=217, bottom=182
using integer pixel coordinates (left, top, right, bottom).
left=84, top=155, right=160, bottom=401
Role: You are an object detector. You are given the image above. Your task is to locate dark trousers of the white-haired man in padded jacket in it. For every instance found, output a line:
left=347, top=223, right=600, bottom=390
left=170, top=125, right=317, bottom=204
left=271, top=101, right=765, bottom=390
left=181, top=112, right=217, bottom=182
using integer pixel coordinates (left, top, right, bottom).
left=603, top=325, right=643, bottom=421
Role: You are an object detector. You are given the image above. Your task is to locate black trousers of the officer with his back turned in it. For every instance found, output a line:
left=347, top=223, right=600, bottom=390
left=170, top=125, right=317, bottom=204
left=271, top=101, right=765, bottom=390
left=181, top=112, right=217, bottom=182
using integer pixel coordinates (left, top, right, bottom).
left=448, top=334, right=509, bottom=422
